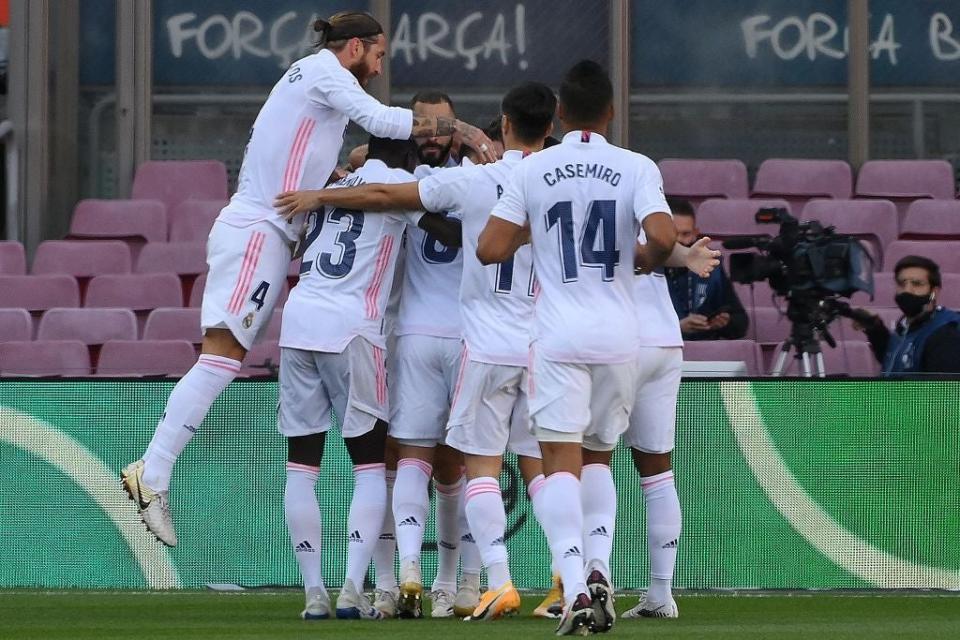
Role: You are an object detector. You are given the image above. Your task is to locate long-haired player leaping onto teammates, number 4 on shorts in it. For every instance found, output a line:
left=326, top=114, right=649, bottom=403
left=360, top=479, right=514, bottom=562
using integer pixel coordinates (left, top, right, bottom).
left=122, top=12, right=492, bottom=546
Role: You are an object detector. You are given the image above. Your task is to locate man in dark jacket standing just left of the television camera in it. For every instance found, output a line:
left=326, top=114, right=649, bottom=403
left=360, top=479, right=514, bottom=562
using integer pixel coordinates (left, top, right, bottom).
left=664, top=198, right=748, bottom=340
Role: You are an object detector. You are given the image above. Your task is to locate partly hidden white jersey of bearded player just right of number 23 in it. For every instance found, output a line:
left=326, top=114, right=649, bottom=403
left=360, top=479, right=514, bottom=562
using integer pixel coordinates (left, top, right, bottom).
left=394, top=159, right=463, bottom=338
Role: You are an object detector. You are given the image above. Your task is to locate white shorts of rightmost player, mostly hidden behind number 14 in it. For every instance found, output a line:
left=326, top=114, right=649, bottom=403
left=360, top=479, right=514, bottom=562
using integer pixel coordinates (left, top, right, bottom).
left=623, top=347, right=683, bottom=453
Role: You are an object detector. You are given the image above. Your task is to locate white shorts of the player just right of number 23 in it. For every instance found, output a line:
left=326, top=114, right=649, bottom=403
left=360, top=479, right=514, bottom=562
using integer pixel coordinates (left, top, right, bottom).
left=389, top=334, right=463, bottom=447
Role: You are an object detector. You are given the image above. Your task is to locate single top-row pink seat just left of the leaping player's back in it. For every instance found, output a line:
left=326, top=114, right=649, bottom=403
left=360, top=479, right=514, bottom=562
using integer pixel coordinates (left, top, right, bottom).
left=133, top=160, right=227, bottom=211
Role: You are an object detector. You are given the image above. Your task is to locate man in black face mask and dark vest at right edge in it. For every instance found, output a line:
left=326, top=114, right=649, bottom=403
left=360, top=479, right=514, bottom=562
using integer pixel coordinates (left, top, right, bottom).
left=854, top=256, right=960, bottom=375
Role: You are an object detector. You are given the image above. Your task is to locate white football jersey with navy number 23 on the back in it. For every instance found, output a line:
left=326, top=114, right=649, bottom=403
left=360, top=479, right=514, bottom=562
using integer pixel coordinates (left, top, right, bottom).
left=280, top=160, right=423, bottom=353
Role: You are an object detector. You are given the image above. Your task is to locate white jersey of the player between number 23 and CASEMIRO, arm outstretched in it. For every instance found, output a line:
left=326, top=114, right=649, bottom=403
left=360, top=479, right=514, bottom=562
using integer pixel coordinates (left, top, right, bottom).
left=419, top=151, right=536, bottom=367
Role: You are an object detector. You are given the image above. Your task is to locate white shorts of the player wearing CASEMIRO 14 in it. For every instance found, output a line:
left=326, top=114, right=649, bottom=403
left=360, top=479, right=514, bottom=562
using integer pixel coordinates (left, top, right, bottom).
left=528, top=350, right=638, bottom=451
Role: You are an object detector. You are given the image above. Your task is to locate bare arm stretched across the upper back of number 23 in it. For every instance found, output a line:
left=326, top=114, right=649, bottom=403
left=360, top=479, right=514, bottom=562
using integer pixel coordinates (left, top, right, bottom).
left=273, top=182, right=423, bottom=219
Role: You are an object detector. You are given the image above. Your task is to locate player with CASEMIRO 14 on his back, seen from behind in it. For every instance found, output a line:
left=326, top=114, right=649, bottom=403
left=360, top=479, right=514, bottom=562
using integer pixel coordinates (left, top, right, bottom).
left=477, top=61, right=676, bottom=635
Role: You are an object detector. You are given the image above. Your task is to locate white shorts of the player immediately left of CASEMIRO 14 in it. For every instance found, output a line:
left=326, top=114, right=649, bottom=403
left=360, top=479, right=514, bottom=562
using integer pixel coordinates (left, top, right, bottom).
left=447, top=359, right=541, bottom=459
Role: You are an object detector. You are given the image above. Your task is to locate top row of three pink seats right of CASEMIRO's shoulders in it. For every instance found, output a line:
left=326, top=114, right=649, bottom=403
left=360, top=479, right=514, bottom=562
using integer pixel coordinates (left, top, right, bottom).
left=658, top=159, right=956, bottom=212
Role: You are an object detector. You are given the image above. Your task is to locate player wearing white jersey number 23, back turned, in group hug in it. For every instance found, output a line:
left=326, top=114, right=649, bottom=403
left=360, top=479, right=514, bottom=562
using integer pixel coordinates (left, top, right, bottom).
left=278, top=138, right=459, bottom=619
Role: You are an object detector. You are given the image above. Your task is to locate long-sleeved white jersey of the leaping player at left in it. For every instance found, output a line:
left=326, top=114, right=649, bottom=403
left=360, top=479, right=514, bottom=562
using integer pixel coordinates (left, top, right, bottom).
left=217, top=49, right=413, bottom=240
